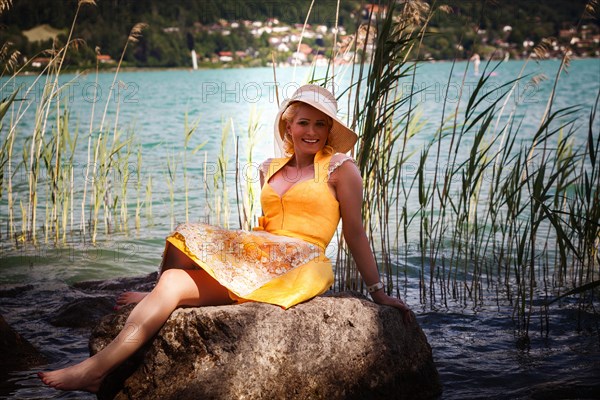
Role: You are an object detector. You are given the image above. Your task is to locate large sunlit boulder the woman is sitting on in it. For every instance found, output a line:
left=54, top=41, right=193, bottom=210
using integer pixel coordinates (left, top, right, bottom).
left=90, top=294, right=441, bottom=400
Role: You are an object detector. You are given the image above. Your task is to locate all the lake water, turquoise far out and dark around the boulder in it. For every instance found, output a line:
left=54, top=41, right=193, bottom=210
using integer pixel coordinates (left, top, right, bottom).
left=0, top=59, right=600, bottom=399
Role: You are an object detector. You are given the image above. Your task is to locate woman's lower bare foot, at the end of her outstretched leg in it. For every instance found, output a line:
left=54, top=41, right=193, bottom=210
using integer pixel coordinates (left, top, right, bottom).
left=38, top=359, right=104, bottom=393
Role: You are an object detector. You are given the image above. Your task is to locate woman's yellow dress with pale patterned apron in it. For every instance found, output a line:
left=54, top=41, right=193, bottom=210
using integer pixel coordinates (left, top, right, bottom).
left=167, top=152, right=351, bottom=308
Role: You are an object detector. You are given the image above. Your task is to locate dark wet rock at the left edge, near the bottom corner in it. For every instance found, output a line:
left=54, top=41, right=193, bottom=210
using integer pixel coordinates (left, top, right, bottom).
left=0, top=315, right=46, bottom=378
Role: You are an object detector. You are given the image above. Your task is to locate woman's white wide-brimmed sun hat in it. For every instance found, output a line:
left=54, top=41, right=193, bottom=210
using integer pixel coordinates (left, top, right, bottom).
left=275, top=85, right=358, bottom=156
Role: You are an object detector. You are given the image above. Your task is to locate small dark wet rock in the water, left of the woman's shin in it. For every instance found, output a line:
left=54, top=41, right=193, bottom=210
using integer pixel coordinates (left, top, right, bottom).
left=50, top=296, right=115, bottom=328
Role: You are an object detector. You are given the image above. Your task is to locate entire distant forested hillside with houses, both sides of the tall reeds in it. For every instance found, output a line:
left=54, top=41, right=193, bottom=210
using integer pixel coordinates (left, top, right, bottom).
left=0, top=0, right=600, bottom=67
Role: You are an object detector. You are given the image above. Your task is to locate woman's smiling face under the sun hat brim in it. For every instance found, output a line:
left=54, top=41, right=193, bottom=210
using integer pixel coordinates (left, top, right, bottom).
left=287, top=104, right=331, bottom=154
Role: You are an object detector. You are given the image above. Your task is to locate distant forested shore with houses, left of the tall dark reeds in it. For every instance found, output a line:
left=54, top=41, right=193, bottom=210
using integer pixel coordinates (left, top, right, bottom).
left=0, top=0, right=360, bottom=67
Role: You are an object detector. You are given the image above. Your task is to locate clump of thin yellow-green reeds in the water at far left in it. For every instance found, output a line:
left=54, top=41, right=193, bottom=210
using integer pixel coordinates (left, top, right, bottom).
left=0, top=0, right=154, bottom=243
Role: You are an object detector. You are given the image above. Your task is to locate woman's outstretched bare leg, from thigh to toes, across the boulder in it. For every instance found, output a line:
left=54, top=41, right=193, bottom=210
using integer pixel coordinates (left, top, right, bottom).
left=38, top=269, right=232, bottom=392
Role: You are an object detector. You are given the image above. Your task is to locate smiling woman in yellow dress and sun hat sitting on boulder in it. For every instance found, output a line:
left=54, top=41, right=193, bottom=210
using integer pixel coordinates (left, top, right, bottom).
left=39, top=85, right=411, bottom=392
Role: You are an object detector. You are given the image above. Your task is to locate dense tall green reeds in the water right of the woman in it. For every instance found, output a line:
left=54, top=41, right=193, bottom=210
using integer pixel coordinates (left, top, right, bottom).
left=336, top=2, right=600, bottom=337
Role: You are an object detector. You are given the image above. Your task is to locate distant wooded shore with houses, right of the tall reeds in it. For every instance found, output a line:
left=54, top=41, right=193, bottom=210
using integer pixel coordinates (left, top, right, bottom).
left=421, top=0, right=600, bottom=60
